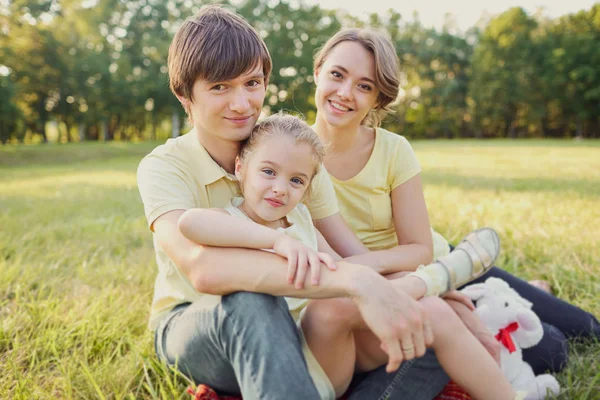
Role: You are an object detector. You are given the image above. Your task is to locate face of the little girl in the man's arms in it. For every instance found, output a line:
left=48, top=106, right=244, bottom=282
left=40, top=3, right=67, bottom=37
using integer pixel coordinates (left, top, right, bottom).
left=235, top=134, right=316, bottom=227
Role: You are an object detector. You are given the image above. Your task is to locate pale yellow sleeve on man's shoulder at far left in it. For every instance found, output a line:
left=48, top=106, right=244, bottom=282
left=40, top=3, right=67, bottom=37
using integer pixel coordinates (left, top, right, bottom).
left=137, top=154, right=195, bottom=229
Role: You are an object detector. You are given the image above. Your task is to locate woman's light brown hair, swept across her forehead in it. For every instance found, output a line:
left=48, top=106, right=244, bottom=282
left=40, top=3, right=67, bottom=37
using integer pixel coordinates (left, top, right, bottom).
left=313, top=28, right=400, bottom=126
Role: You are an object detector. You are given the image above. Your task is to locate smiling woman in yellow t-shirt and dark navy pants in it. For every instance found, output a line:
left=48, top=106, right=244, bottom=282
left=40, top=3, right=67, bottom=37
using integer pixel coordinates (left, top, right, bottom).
left=313, top=29, right=600, bottom=373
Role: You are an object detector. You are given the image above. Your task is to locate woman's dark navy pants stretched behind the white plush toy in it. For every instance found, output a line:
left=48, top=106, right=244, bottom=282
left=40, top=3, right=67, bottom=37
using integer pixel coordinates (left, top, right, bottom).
left=462, top=267, right=600, bottom=374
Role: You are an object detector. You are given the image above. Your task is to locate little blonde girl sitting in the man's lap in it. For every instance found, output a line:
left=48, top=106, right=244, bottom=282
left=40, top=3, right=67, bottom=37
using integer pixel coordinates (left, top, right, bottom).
left=179, top=114, right=516, bottom=400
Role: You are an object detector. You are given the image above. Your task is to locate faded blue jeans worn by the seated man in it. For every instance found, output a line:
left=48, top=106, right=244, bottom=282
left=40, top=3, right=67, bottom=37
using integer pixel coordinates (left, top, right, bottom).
left=155, top=292, right=449, bottom=400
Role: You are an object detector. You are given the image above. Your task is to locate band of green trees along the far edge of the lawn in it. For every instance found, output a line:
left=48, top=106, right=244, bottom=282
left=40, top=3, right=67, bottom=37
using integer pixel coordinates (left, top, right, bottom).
left=0, top=0, right=600, bottom=143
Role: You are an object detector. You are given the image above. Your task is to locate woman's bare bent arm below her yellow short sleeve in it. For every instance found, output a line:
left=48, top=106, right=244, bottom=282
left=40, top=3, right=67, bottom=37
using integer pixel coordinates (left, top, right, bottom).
left=345, top=174, right=433, bottom=275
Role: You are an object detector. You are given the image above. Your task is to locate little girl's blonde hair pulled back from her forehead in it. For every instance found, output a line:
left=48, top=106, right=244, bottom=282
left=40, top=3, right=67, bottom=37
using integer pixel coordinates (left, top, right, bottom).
left=239, top=112, right=325, bottom=179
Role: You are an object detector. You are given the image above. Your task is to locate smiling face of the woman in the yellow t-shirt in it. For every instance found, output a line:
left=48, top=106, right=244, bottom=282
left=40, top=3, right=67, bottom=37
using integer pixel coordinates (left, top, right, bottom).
left=315, top=41, right=379, bottom=128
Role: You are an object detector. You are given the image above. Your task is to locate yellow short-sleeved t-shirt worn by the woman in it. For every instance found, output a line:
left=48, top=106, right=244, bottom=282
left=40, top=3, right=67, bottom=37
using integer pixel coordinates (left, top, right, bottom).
left=331, top=128, right=449, bottom=258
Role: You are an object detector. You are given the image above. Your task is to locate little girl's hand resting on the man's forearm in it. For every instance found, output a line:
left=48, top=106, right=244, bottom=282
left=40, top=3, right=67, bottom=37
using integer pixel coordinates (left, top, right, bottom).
left=273, top=234, right=337, bottom=289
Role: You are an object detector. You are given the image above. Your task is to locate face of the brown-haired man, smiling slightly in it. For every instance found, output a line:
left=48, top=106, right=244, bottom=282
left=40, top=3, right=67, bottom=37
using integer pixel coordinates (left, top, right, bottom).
left=189, top=65, right=266, bottom=142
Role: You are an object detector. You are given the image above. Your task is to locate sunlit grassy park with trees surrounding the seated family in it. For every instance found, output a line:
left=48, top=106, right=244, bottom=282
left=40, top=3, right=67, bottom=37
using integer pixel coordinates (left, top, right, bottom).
left=0, top=0, right=600, bottom=400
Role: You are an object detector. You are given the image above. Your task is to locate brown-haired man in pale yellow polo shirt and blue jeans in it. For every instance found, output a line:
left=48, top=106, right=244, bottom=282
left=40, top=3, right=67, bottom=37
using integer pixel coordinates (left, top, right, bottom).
left=138, top=6, right=448, bottom=399
